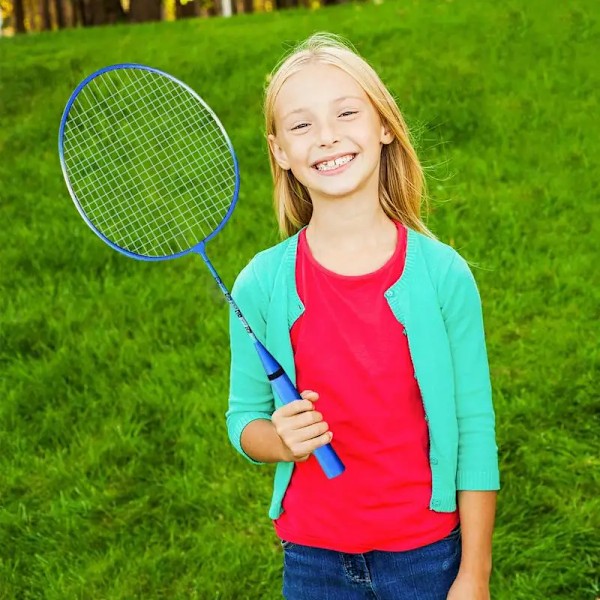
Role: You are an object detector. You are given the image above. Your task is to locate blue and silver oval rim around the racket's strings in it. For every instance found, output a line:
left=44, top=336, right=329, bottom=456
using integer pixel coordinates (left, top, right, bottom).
left=58, top=63, right=240, bottom=261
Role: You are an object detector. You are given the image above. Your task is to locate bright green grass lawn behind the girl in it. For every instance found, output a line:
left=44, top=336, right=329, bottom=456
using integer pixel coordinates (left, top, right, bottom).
left=0, top=0, right=600, bottom=600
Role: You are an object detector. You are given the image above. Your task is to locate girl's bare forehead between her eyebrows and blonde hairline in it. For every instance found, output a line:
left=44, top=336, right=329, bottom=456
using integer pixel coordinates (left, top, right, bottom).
left=275, top=63, right=368, bottom=118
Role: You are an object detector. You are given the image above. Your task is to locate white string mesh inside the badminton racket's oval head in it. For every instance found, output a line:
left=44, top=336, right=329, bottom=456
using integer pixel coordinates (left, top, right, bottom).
left=65, top=69, right=237, bottom=255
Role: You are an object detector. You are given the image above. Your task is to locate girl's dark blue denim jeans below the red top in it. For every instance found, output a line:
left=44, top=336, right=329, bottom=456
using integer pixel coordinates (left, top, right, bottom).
left=282, top=524, right=461, bottom=600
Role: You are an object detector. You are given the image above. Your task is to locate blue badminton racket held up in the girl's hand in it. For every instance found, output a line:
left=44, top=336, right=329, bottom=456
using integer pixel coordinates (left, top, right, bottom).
left=59, top=64, right=344, bottom=478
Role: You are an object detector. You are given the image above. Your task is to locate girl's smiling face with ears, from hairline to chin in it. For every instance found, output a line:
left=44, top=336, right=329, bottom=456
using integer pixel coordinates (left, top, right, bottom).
left=269, top=63, right=393, bottom=204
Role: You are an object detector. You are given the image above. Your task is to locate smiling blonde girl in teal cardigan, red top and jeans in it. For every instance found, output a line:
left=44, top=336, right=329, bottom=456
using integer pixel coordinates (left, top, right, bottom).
left=227, top=34, right=499, bottom=600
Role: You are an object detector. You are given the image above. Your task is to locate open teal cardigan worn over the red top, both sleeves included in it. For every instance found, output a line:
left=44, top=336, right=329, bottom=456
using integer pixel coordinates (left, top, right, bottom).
left=226, top=229, right=500, bottom=519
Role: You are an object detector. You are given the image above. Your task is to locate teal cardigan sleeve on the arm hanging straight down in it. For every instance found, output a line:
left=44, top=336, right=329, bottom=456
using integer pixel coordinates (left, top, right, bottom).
left=441, top=252, right=500, bottom=490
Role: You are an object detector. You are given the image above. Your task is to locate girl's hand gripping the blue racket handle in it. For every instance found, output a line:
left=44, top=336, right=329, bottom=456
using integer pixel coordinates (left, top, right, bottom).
left=271, top=390, right=333, bottom=462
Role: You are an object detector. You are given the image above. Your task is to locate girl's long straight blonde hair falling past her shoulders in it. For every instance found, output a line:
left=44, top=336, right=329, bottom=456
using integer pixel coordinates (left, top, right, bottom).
left=264, top=33, right=437, bottom=239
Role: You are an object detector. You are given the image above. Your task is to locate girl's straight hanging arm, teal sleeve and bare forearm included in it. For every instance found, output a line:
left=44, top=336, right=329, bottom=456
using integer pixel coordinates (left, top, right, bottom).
left=442, top=254, right=500, bottom=600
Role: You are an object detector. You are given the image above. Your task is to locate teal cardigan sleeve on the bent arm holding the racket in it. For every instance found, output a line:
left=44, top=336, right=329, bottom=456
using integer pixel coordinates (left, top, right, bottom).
left=226, top=261, right=275, bottom=464
